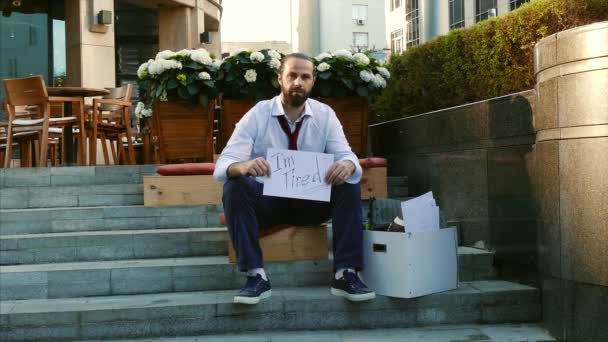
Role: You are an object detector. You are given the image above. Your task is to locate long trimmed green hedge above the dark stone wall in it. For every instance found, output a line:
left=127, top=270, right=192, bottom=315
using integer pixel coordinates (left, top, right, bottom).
left=370, top=0, right=608, bottom=122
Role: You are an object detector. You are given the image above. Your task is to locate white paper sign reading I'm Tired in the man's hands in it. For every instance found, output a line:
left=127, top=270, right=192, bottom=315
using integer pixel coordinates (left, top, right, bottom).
left=263, top=148, right=334, bottom=202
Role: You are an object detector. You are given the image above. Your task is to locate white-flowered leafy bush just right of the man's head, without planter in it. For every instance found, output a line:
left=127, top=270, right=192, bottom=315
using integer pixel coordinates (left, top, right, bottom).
left=313, top=50, right=391, bottom=98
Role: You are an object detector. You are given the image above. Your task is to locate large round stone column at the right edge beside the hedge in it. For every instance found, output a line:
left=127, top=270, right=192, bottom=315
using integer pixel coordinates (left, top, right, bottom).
left=534, top=22, right=608, bottom=341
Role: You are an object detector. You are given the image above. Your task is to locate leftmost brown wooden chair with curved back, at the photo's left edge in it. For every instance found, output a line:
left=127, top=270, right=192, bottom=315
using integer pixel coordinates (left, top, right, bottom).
left=2, top=76, right=51, bottom=168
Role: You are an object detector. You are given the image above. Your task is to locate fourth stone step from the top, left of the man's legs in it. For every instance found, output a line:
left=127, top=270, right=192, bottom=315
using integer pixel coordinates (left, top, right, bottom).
left=0, top=228, right=228, bottom=265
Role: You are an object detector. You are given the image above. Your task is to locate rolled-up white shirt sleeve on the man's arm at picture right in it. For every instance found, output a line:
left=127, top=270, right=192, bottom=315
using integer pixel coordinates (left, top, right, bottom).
left=325, top=109, right=363, bottom=184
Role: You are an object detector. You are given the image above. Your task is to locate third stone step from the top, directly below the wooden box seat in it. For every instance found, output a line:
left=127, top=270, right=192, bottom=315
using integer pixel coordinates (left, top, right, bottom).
left=0, top=205, right=222, bottom=236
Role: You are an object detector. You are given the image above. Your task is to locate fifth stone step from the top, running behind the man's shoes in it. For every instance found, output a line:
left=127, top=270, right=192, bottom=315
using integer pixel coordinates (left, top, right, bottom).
left=0, top=246, right=493, bottom=300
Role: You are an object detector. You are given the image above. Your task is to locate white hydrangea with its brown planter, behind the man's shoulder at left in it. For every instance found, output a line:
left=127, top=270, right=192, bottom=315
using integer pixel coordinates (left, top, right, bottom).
left=218, top=49, right=283, bottom=148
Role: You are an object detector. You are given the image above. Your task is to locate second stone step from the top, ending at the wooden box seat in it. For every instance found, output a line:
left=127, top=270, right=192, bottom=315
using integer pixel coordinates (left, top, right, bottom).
left=0, top=184, right=144, bottom=209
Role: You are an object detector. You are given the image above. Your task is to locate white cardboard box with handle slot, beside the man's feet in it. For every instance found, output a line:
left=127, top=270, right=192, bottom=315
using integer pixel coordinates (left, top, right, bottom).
left=361, top=227, right=458, bottom=298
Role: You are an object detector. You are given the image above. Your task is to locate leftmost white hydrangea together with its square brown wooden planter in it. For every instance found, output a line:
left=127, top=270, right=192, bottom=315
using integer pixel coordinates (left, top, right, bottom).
left=135, top=49, right=220, bottom=163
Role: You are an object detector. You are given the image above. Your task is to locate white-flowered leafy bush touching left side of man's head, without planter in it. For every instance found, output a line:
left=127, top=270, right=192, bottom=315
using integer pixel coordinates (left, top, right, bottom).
left=218, top=49, right=283, bottom=102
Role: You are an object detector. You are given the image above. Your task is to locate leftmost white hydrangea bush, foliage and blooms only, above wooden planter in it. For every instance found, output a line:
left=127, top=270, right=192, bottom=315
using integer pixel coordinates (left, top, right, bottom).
left=135, top=49, right=221, bottom=119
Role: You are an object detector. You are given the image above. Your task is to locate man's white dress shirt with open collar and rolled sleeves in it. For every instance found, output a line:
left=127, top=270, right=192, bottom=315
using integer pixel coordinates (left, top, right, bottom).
left=213, top=95, right=363, bottom=184
